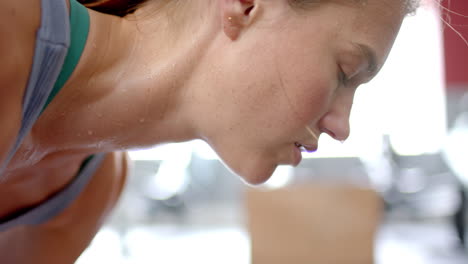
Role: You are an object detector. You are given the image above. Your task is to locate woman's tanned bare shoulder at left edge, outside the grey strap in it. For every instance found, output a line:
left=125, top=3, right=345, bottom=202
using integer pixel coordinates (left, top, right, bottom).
left=0, top=0, right=40, bottom=164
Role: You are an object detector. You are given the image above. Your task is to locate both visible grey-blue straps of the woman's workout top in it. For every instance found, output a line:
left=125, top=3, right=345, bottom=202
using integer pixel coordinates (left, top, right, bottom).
left=0, top=0, right=105, bottom=231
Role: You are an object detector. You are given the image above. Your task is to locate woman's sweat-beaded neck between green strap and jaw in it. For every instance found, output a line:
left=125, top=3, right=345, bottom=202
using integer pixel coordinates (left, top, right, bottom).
left=37, top=1, right=216, bottom=151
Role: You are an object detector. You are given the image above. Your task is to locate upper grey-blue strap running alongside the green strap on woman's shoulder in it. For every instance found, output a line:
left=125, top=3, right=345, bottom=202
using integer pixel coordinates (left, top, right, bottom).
left=0, top=0, right=70, bottom=179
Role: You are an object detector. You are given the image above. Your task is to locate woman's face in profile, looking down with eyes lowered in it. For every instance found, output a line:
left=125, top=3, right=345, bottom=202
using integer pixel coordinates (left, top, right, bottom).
left=194, top=0, right=404, bottom=184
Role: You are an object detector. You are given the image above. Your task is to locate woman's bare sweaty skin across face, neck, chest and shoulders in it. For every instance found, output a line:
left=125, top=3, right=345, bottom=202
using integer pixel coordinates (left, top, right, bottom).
left=0, top=0, right=403, bottom=264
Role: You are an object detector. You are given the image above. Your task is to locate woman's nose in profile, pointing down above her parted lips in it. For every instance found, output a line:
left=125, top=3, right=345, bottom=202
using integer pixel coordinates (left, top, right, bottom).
left=318, top=93, right=353, bottom=141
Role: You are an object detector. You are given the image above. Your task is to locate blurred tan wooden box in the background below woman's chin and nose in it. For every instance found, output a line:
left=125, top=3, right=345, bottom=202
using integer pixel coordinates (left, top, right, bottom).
left=246, top=185, right=382, bottom=264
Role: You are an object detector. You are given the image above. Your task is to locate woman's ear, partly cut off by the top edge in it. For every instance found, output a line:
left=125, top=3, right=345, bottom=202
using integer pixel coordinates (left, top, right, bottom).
left=220, top=0, right=257, bottom=40
